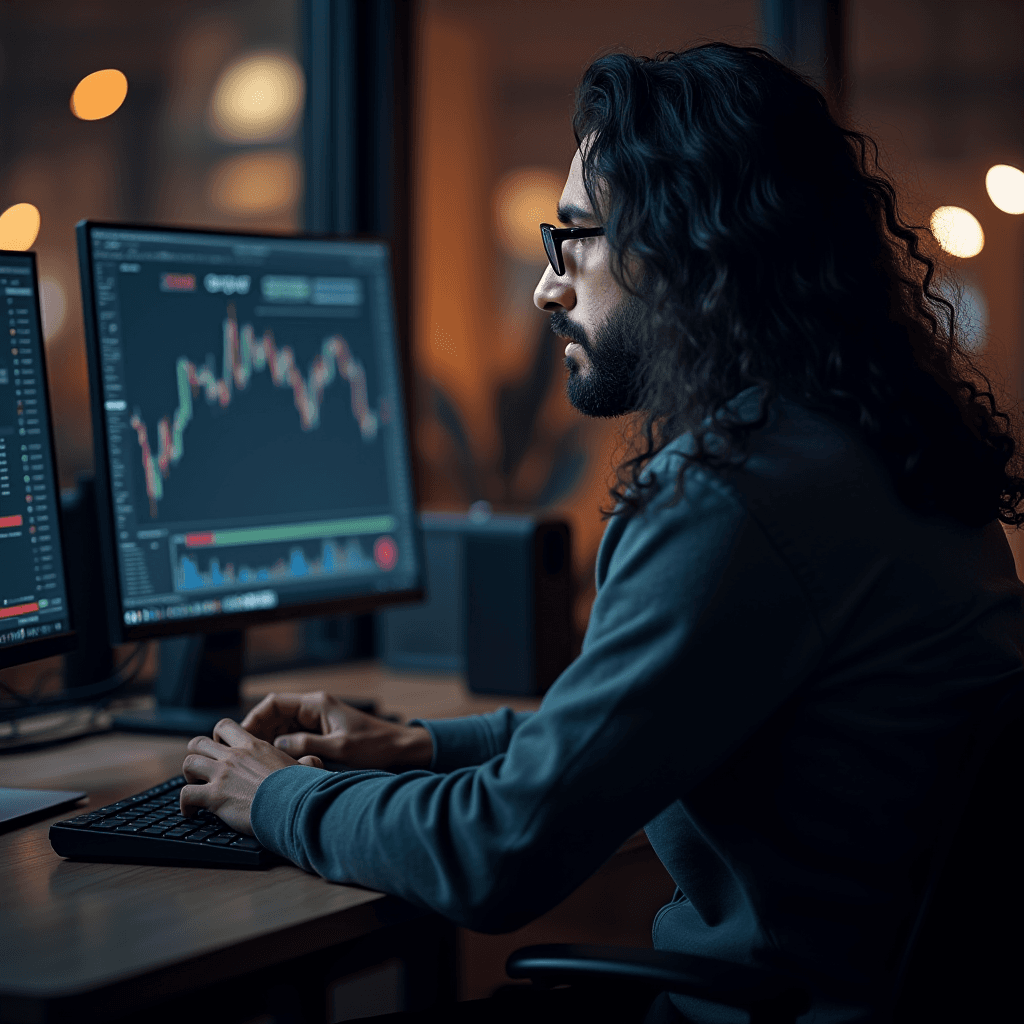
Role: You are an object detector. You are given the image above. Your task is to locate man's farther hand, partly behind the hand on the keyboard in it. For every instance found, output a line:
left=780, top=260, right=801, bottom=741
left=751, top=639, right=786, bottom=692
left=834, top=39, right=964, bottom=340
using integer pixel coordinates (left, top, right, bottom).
left=242, top=693, right=434, bottom=771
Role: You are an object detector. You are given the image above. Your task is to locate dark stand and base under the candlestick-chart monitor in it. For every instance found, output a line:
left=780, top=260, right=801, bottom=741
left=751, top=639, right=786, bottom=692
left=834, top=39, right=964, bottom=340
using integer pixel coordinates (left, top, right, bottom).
left=112, top=630, right=245, bottom=736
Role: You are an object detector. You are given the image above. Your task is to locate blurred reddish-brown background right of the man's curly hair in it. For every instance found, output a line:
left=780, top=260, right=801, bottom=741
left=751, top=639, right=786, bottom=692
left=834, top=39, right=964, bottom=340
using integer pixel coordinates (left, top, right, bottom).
left=847, top=0, right=1024, bottom=575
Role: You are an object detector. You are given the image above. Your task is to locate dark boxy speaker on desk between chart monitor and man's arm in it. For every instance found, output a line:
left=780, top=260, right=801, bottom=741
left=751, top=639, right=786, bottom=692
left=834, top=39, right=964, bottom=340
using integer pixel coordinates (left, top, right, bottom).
left=377, top=511, right=572, bottom=696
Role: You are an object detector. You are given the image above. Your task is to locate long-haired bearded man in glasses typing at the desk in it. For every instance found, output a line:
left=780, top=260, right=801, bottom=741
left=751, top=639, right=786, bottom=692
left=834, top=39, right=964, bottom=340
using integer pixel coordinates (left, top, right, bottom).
left=181, top=44, right=1024, bottom=1022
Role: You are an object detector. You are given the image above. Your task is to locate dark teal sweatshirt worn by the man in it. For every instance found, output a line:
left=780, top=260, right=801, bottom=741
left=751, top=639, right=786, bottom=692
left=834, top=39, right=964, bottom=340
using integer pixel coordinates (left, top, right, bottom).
left=252, top=394, right=1024, bottom=1024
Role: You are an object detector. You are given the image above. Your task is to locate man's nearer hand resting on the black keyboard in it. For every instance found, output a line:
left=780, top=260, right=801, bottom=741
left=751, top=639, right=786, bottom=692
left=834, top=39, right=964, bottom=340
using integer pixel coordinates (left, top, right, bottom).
left=180, top=718, right=324, bottom=836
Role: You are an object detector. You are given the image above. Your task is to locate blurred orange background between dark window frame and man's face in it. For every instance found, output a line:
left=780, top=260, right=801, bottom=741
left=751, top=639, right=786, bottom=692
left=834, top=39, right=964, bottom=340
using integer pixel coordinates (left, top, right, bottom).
left=414, top=0, right=760, bottom=640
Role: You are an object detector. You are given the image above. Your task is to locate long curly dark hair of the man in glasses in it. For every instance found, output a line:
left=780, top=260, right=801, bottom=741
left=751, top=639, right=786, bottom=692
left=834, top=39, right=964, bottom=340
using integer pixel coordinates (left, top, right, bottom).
left=572, top=43, right=1024, bottom=525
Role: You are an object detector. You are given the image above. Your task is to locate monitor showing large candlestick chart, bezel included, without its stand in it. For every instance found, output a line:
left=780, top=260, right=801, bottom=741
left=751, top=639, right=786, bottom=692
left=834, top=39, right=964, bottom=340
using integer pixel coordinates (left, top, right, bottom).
left=79, top=223, right=423, bottom=639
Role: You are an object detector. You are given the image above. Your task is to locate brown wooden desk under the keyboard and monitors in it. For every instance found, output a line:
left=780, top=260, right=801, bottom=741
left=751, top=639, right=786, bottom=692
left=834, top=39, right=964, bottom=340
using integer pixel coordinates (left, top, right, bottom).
left=0, top=663, right=671, bottom=1024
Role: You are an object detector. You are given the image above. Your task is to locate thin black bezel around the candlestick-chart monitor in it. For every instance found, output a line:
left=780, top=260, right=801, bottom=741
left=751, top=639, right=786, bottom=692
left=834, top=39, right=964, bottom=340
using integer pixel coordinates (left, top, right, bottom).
left=75, top=219, right=426, bottom=644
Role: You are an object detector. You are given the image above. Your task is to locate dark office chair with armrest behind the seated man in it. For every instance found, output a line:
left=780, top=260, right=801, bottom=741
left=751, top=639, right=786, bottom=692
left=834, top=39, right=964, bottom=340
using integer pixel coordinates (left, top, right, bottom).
left=506, top=693, right=1024, bottom=1024
